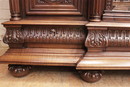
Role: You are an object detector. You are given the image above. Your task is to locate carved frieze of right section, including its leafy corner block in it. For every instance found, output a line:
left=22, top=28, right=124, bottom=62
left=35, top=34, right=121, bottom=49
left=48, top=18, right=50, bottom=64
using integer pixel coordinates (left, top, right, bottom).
left=86, top=28, right=130, bottom=47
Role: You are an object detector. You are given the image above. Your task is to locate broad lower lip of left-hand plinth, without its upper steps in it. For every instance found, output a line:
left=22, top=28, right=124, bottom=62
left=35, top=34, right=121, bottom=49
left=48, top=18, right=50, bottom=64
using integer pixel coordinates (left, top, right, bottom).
left=0, top=55, right=80, bottom=66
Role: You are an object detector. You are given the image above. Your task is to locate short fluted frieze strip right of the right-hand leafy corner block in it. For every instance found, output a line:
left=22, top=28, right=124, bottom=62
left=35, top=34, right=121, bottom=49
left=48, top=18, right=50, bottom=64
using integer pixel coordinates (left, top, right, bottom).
left=108, top=30, right=130, bottom=47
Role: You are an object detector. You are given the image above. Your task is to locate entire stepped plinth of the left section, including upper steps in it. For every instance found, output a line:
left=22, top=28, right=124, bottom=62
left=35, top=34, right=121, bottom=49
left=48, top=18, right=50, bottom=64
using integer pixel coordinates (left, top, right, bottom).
left=0, top=48, right=85, bottom=66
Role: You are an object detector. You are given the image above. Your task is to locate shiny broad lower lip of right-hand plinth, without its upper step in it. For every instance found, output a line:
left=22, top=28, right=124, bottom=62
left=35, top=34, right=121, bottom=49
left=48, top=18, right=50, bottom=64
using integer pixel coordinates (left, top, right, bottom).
left=76, top=57, right=130, bottom=70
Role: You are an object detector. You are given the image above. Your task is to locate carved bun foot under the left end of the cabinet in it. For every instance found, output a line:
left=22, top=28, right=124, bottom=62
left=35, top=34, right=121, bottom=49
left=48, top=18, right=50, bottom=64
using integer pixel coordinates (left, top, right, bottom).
left=8, top=64, right=32, bottom=77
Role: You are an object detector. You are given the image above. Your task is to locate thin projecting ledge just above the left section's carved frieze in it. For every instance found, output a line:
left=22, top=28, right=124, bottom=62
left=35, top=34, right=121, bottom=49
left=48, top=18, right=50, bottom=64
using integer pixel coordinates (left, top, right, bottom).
left=2, top=20, right=88, bottom=25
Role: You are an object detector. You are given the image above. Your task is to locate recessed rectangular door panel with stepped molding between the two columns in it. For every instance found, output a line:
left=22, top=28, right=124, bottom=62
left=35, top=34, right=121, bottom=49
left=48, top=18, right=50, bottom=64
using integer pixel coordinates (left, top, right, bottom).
left=25, top=0, right=87, bottom=15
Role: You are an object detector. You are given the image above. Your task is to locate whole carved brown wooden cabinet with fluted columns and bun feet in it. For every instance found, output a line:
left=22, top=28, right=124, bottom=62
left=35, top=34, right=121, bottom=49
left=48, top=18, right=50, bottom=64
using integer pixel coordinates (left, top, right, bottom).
left=0, top=0, right=130, bottom=82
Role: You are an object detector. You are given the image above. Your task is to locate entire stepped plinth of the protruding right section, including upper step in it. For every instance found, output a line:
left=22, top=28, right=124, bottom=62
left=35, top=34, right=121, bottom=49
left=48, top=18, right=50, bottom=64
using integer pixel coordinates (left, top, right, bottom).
left=77, top=52, right=130, bottom=70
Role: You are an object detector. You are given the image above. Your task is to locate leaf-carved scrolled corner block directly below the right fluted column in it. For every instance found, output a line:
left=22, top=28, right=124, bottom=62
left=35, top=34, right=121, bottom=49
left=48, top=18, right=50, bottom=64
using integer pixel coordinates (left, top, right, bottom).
left=85, top=27, right=108, bottom=51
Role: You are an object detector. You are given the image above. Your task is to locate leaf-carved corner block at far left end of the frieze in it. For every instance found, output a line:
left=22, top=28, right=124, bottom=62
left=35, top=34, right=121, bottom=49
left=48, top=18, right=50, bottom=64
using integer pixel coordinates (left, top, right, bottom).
left=3, top=25, right=24, bottom=47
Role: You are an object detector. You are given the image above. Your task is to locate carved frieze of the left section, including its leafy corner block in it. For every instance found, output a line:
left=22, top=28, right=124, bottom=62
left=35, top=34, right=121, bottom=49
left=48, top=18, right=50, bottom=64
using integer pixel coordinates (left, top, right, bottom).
left=4, top=26, right=87, bottom=44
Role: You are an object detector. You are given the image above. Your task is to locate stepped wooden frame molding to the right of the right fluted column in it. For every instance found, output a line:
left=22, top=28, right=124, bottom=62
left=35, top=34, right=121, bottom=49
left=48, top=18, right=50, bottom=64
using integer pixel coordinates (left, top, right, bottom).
left=103, top=0, right=130, bottom=22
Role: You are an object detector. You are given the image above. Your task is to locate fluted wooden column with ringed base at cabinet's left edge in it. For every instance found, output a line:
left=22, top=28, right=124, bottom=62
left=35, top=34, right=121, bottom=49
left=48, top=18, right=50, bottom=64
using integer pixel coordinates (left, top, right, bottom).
left=10, top=0, right=21, bottom=21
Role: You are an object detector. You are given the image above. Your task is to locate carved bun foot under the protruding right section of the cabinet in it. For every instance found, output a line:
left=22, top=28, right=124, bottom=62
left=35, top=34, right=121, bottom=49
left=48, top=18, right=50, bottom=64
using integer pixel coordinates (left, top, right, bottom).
left=79, top=71, right=102, bottom=83
